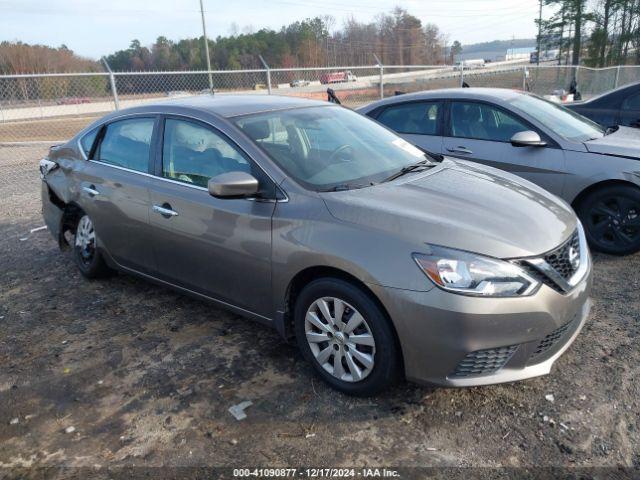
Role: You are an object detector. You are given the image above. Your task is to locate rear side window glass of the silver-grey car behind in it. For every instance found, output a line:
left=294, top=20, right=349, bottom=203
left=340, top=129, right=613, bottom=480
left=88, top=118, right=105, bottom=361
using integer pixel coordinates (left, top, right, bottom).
left=378, top=102, right=440, bottom=135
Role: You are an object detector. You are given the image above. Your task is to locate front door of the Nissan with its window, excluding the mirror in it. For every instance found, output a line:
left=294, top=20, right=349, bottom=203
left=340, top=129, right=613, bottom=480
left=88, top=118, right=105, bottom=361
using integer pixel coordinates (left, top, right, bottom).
left=149, top=117, right=275, bottom=316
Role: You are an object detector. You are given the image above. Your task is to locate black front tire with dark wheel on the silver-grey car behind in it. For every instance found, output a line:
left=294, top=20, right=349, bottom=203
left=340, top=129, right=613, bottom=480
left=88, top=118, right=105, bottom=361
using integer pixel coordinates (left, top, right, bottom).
left=577, top=185, right=640, bottom=255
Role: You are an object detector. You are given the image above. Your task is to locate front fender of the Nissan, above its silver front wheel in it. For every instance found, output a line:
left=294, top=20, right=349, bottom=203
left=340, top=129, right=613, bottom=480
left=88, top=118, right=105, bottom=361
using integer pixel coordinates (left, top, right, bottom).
left=272, top=191, right=434, bottom=311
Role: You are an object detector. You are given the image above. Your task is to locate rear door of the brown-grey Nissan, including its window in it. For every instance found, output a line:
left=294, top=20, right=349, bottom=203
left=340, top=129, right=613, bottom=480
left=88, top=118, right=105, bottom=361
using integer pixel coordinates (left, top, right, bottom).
left=76, top=116, right=158, bottom=273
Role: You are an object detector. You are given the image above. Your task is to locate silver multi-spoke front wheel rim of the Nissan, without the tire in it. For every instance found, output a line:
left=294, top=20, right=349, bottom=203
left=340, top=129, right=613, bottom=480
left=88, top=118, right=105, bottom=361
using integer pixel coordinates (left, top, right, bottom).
left=304, top=297, right=376, bottom=382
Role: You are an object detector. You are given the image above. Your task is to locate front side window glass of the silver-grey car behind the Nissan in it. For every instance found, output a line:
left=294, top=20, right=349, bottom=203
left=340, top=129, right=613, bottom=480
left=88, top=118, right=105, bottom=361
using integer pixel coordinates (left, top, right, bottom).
left=451, top=102, right=531, bottom=142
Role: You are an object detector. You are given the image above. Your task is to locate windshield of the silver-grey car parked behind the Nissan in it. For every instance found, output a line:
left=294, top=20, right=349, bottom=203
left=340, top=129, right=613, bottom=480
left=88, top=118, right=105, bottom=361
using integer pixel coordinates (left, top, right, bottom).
left=509, top=95, right=605, bottom=142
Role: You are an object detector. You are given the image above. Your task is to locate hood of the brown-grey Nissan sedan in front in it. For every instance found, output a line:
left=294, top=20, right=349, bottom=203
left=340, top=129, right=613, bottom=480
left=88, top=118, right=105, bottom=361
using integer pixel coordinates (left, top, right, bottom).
left=321, top=159, right=577, bottom=258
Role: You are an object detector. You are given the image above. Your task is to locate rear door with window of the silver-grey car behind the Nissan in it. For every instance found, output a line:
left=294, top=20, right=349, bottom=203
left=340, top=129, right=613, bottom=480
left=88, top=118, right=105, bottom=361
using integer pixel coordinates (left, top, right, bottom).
left=376, top=100, right=443, bottom=153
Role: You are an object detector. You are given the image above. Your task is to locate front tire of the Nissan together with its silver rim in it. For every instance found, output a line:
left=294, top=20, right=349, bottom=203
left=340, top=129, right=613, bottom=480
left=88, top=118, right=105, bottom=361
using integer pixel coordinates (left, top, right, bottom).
left=294, top=278, right=401, bottom=396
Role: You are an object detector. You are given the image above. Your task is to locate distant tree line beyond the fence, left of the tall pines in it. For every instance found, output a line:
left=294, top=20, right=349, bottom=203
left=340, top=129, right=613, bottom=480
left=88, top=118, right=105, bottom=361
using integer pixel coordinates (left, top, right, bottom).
left=0, top=8, right=448, bottom=73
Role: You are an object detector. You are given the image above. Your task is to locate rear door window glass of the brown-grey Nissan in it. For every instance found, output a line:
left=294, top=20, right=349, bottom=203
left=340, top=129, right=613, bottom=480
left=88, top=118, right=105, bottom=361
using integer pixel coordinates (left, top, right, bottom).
left=94, top=118, right=155, bottom=172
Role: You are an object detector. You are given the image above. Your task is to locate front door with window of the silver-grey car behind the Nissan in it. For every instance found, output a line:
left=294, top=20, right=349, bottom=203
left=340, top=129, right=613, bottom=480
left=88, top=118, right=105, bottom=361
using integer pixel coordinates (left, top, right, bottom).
left=443, top=101, right=565, bottom=195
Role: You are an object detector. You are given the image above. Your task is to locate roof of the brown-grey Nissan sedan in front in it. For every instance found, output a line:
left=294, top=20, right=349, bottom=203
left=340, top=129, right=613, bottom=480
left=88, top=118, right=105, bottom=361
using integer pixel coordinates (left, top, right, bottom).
left=126, top=93, right=333, bottom=118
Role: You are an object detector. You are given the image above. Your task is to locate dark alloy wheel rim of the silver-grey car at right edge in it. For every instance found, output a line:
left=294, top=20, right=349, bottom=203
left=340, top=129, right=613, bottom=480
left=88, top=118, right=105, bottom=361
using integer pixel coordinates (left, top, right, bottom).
left=587, top=196, right=640, bottom=248
